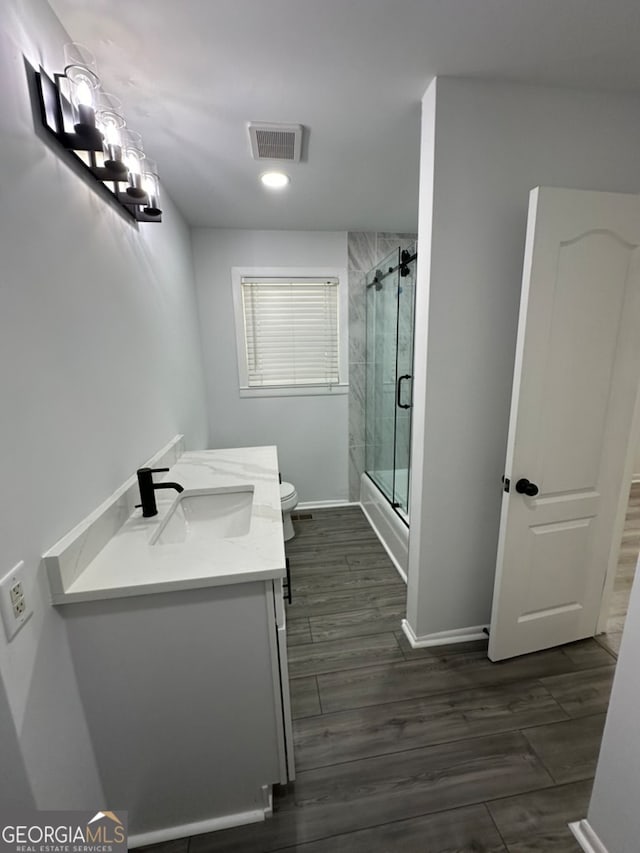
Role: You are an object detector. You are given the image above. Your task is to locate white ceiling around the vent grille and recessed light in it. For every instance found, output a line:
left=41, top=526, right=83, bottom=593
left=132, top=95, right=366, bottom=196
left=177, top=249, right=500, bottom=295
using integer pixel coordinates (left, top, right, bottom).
left=49, top=0, right=640, bottom=231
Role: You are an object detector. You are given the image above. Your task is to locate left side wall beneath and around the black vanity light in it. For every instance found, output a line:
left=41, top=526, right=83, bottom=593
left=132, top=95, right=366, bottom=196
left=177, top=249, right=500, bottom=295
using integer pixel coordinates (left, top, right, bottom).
left=0, top=0, right=207, bottom=809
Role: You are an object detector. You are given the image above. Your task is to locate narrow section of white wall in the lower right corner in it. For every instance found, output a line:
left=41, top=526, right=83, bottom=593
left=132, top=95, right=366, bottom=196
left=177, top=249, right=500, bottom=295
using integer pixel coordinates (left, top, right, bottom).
left=588, top=564, right=640, bottom=853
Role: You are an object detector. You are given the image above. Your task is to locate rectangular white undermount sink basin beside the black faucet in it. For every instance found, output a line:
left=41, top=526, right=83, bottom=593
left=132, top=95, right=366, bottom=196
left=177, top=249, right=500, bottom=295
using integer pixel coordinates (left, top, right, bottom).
left=149, top=486, right=254, bottom=545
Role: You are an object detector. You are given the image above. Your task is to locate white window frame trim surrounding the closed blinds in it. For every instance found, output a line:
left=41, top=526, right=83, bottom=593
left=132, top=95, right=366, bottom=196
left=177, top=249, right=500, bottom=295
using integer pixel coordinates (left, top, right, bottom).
left=231, top=267, right=349, bottom=397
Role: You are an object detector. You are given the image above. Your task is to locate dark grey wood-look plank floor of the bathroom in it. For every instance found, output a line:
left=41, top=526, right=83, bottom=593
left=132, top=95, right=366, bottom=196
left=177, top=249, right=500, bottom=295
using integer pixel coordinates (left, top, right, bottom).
left=161, top=508, right=615, bottom=853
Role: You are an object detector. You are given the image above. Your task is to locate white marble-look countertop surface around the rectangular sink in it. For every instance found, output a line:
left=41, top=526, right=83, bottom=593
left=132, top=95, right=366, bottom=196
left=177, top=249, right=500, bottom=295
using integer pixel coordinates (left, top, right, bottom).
left=50, top=447, right=285, bottom=604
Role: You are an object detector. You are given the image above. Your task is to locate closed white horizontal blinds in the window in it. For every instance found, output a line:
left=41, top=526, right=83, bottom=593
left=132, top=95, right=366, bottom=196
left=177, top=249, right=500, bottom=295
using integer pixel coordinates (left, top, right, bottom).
left=241, top=277, right=340, bottom=388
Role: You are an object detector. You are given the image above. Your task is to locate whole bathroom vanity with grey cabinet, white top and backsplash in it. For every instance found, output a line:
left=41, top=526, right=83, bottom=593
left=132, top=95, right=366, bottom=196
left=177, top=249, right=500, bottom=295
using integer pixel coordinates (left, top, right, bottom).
left=45, top=447, right=294, bottom=846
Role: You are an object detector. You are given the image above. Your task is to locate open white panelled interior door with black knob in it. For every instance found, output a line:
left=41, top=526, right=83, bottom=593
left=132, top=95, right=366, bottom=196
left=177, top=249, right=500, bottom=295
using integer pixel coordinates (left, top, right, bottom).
left=489, top=188, right=640, bottom=660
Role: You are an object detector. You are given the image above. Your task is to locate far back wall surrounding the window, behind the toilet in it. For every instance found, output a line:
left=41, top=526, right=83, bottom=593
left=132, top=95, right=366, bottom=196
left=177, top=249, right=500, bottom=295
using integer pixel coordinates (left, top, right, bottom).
left=192, top=228, right=348, bottom=501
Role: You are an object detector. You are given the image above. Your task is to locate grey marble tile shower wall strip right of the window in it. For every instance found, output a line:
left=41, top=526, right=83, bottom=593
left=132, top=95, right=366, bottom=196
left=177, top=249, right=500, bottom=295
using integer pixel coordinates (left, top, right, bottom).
left=347, top=231, right=416, bottom=501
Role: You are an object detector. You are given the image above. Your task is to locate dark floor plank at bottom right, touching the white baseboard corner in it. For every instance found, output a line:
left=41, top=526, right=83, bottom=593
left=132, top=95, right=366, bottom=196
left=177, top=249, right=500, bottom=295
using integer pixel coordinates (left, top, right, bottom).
left=488, top=780, right=592, bottom=853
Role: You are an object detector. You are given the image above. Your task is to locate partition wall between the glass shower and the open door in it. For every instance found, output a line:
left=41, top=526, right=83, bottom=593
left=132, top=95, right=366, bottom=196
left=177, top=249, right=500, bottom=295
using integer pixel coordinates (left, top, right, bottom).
left=408, top=78, right=640, bottom=636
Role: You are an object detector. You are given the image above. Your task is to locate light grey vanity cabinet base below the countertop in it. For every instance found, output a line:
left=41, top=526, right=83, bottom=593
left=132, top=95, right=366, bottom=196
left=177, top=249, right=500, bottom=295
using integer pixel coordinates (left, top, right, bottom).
left=62, top=579, right=293, bottom=846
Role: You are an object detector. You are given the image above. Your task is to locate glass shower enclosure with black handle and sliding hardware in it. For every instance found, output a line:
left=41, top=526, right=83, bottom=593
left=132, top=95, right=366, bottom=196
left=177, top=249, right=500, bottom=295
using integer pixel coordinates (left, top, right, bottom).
left=365, top=244, right=417, bottom=524
